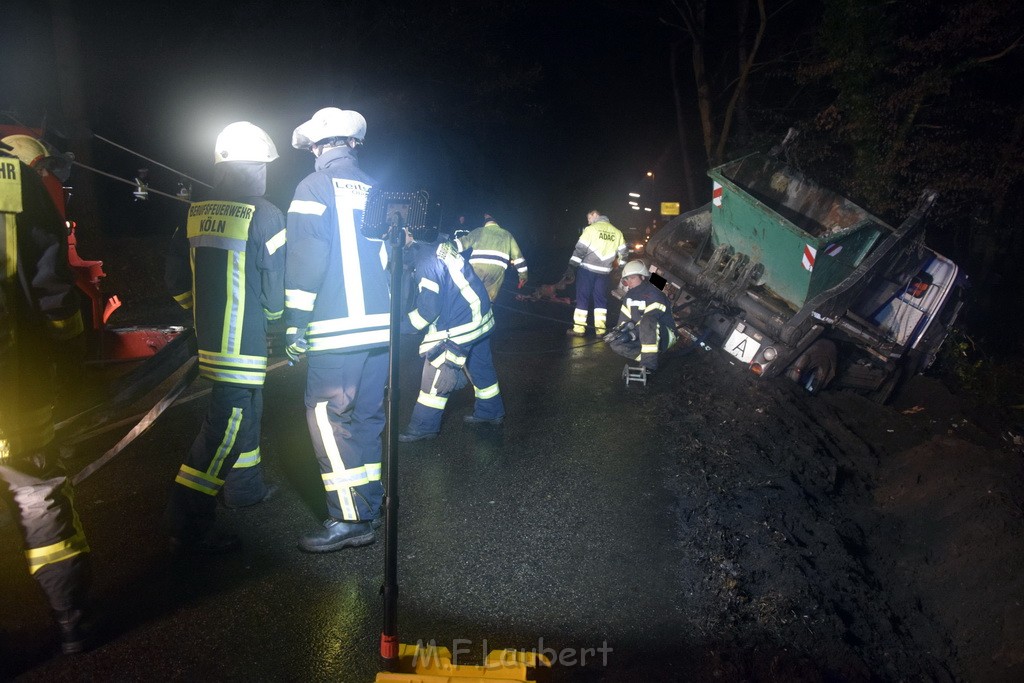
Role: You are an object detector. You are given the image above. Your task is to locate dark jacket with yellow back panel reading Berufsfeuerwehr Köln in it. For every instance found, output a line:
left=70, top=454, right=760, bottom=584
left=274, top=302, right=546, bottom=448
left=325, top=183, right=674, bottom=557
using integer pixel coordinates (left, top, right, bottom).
left=167, top=160, right=286, bottom=387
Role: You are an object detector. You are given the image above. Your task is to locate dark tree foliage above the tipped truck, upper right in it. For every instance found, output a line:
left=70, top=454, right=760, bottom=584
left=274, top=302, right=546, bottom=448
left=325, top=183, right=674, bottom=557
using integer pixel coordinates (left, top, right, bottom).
left=796, top=0, right=1024, bottom=278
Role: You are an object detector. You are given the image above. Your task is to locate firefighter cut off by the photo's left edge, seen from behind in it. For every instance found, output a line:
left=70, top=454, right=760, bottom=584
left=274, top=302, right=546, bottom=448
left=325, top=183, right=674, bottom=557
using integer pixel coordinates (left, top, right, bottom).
left=0, top=144, right=89, bottom=653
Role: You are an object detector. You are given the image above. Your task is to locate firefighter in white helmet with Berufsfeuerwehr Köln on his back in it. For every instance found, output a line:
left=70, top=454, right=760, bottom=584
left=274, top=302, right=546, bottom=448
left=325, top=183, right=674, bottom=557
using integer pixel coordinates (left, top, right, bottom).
left=166, top=121, right=286, bottom=553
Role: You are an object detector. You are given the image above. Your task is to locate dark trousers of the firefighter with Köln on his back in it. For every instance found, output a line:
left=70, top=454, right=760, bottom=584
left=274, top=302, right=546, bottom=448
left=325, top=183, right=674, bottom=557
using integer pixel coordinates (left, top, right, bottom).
left=166, top=382, right=263, bottom=539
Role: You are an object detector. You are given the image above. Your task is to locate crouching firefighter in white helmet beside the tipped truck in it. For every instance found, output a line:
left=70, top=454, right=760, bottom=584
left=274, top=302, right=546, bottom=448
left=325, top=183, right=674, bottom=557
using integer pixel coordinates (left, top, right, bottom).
left=604, top=261, right=677, bottom=372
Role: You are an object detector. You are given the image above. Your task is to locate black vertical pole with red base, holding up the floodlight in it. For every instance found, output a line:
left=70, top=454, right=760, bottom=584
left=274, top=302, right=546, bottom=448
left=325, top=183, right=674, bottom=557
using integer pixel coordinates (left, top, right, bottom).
left=381, top=228, right=406, bottom=671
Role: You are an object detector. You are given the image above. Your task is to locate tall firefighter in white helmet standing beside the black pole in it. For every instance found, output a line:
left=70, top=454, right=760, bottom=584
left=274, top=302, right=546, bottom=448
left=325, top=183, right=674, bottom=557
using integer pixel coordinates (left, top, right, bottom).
left=285, top=106, right=391, bottom=553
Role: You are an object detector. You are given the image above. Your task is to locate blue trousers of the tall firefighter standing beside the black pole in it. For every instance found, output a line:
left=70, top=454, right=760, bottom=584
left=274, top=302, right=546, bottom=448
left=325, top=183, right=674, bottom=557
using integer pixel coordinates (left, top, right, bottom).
left=305, top=348, right=388, bottom=521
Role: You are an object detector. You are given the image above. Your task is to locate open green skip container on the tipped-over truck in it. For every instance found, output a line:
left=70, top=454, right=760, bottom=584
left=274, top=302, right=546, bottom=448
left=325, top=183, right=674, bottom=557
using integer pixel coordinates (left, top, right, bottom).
left=708, top=154, right=893, bottom=309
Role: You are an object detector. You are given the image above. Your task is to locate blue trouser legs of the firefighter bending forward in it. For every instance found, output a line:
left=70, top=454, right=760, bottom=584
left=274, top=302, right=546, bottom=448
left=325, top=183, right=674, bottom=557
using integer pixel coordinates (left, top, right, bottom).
left=409, top=337, right=505, bottom=433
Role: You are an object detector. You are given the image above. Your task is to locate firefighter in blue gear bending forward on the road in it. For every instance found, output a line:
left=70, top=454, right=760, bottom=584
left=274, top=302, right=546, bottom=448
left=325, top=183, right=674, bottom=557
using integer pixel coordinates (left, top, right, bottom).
left=398, top=242, right=505, bottom=442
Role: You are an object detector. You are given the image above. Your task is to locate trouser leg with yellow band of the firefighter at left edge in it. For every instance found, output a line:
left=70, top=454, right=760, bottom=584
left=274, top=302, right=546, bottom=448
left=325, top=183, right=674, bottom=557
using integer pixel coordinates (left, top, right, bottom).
left=0, top=413, right=89, bottom=610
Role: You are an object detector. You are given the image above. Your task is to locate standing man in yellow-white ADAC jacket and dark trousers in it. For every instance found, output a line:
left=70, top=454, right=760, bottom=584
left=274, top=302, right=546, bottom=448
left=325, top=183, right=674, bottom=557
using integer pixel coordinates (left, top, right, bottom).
left=564, top=210, right=627, bottom=337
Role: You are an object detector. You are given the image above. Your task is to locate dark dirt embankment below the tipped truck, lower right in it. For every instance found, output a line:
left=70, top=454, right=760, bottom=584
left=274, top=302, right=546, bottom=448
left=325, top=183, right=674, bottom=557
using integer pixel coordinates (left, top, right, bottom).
left=654, top=358, right=1024, bottom=681
